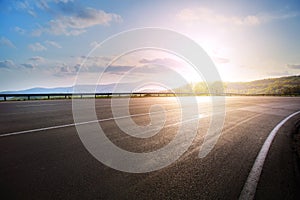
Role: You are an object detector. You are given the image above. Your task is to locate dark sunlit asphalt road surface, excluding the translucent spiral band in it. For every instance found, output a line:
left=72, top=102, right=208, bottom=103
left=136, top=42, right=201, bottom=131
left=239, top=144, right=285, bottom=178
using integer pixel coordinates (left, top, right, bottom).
left=0, top=97, right=300, bottom=199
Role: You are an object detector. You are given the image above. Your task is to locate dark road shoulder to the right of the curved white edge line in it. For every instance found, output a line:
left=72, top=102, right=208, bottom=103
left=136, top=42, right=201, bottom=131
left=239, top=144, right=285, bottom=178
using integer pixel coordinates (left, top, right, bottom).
left=255, top=115, right=300, bottom=199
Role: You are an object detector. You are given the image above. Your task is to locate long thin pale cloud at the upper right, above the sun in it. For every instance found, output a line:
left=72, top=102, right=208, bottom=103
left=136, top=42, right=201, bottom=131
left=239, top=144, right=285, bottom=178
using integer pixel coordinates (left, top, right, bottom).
left=177, top=7, right=300, bottom=26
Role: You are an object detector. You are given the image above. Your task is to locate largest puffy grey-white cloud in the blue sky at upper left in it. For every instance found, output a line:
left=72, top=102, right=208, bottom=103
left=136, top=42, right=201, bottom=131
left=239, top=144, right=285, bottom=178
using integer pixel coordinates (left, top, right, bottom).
left=34, top=8, right=122, bottom=35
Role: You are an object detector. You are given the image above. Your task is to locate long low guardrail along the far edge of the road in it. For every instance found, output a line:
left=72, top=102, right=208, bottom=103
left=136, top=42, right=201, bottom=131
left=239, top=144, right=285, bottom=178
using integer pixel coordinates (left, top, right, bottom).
left=0, top=92, right=299, bottom=101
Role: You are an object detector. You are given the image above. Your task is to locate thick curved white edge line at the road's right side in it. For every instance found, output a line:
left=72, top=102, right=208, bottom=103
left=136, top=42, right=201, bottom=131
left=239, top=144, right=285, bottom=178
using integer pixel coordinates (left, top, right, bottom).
left=239, top=111, right=300, bottom=200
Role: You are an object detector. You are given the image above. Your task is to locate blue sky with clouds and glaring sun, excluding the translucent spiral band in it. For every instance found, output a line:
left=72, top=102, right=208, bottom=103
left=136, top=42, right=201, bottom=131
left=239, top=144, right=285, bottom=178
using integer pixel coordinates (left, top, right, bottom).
left=0, top=0, right=300, bottom=91
